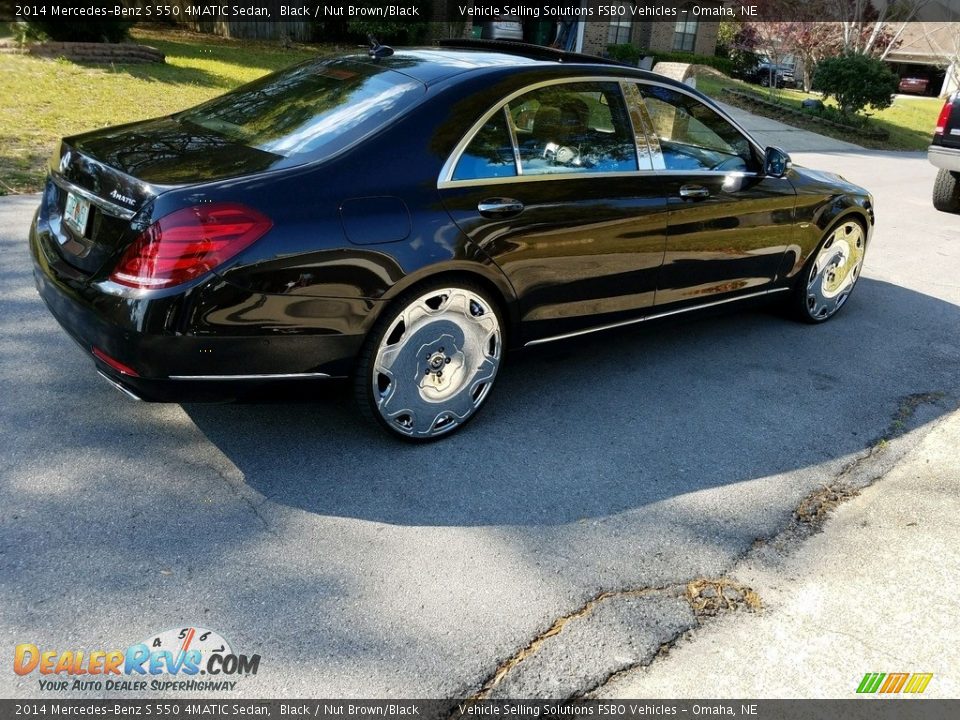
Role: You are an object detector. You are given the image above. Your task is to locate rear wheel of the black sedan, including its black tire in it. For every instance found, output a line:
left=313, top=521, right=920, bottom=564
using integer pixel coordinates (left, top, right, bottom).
left=354, top=281, right=504, bottom=442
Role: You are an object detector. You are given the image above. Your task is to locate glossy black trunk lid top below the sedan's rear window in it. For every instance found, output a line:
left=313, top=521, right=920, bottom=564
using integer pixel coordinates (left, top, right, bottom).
left=66, top=117, right=283, bottom=185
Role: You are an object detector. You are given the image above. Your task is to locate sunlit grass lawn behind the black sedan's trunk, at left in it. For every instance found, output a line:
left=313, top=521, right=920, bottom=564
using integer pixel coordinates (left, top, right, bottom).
left=0, top=30, right=330, bottom=194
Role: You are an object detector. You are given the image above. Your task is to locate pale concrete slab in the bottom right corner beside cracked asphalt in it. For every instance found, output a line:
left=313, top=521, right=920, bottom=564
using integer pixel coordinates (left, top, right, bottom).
left=602, top=411, right=960, bottom=698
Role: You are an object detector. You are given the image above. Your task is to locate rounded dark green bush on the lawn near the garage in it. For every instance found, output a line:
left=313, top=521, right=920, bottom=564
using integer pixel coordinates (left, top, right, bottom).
left=813, top=54, right=899, bottom=116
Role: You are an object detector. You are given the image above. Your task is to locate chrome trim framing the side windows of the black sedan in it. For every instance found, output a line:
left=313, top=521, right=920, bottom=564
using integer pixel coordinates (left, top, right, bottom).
left=437, top=75, right=768, bottom=190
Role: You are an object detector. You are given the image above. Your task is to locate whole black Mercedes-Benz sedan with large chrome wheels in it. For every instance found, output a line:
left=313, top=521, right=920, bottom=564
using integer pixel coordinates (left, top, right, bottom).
left=30, top=40, right=874, bottom=440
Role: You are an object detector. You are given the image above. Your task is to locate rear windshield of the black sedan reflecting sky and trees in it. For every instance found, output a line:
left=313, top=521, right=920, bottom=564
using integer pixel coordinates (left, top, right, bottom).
left=177, top=58, right=426, bottom=160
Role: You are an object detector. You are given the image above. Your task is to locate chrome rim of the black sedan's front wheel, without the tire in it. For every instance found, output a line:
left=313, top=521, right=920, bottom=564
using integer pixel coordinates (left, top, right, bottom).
left=806, top=220, right=866, bottom=321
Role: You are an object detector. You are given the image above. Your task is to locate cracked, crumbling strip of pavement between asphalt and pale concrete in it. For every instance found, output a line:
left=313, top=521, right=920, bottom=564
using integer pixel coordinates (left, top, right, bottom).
left=460, top=392, right=946, bottom=700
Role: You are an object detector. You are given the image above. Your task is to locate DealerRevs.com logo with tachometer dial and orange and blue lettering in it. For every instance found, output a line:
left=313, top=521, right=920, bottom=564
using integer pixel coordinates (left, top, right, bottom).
left=13, top=627, right=260, bottom=692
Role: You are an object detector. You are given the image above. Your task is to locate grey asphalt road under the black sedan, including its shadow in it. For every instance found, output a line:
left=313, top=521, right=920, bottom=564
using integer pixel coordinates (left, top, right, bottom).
left=0, top=152, right=960, bottom=697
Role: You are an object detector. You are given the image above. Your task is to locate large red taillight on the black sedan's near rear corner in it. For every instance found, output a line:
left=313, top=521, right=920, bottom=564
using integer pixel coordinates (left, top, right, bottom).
left=110, top=203, right=273, bottom=288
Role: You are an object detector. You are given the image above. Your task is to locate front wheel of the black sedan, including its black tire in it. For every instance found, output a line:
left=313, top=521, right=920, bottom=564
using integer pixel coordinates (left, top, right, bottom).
left=789, top=218, right=867, bottom=323
